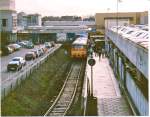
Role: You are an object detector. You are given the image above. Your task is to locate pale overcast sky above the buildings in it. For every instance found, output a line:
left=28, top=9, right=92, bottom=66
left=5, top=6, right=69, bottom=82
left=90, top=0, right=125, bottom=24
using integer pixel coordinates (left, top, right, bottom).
left=16, top=0, right=150, bottom=16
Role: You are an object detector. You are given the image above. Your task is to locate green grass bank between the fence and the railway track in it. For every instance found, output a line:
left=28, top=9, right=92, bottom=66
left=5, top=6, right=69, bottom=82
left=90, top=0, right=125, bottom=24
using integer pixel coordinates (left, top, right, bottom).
left=1, top=47, right=71, bottom=116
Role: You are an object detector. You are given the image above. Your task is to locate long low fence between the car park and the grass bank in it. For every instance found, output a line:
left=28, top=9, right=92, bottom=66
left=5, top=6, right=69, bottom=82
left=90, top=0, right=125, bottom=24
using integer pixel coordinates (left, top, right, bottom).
left=1, top=45, right=61, bottom=99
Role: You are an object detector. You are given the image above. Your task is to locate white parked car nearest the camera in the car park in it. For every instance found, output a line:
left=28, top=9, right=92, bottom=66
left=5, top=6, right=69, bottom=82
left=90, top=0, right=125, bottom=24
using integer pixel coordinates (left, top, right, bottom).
left=7, top=58, right=22, bottom=71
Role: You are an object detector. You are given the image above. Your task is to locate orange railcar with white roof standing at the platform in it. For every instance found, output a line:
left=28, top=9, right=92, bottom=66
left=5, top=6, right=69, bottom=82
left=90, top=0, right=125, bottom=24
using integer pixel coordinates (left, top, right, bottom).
left=71, top=37, right=88, bottom=59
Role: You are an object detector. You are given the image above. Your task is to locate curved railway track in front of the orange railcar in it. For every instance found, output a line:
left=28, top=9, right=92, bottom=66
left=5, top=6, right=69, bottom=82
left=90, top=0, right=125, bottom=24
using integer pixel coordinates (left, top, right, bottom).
left=44, top=62, right=82, bottom=116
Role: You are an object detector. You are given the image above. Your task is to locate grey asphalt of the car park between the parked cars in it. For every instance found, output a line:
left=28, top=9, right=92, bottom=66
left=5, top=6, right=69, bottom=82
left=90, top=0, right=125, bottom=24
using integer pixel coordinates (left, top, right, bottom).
left=1, top=45, right=52, bottom=83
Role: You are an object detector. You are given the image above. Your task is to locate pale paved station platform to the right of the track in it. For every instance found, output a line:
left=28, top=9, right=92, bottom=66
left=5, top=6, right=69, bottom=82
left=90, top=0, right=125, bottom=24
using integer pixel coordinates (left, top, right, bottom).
left=87, top=56, right=132, bottom=116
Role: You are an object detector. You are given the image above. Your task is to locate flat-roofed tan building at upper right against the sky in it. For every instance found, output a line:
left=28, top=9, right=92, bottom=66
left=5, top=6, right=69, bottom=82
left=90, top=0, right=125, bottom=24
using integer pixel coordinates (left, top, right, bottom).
left=95, top=12, right=148, bottom=30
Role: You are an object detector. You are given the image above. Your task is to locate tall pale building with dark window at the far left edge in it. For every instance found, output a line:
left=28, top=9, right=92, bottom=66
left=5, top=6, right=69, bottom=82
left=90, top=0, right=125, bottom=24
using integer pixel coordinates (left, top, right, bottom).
left=0, top=0, right=17, bottom=45
